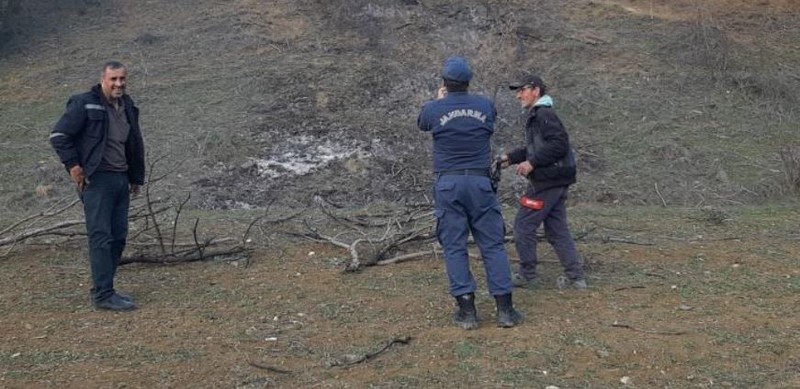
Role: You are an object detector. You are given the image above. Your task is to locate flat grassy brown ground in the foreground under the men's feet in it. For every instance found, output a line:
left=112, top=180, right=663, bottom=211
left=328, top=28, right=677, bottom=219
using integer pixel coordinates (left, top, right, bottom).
left=0, top=206, right=800, bottom=388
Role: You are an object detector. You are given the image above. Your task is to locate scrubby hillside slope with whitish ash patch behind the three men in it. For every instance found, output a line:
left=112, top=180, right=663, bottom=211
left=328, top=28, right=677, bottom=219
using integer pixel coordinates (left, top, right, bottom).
left=0, top=0, right=800, bottom=209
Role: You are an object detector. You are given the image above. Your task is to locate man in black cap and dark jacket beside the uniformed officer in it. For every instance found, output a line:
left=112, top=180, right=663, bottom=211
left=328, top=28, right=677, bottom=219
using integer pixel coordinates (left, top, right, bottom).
left=501, top=75, right=586, bottom=290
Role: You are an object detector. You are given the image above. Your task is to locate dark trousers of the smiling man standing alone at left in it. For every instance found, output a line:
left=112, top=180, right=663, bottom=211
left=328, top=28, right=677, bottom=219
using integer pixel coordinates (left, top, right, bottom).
left=81, top=172, right=130, bottom=302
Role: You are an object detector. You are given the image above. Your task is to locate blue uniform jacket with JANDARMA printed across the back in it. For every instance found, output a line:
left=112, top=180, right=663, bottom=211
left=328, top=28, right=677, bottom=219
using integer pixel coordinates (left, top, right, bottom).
left=417, top=92, right=497, bottom=172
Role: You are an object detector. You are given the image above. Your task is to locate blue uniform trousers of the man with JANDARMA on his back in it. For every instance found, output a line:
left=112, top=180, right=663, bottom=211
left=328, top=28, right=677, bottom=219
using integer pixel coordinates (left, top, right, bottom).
left=434, top=174, right=513, bottom=296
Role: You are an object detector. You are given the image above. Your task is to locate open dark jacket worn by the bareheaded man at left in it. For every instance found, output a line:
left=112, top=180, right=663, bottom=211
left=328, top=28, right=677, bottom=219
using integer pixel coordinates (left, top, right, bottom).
left=50, top=84, right=145, bottom=185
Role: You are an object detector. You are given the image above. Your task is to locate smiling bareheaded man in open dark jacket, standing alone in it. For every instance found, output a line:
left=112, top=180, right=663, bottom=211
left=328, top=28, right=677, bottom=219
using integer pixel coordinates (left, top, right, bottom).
left=50, top=61, right=145, bottom=311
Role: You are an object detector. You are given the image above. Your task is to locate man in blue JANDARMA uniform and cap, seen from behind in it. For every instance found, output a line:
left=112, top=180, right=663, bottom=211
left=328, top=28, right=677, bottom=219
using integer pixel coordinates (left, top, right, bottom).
left=417, top=57, right=523, bottom=330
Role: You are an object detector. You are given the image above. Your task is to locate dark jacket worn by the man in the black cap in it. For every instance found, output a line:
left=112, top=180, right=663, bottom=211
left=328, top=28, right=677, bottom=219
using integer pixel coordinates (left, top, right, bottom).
left=508, top=96, right=577, bottom=192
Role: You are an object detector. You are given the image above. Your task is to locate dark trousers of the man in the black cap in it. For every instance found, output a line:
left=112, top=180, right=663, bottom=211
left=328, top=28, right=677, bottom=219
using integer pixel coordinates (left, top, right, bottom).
left=514, top=186, right=585, bottom=280
